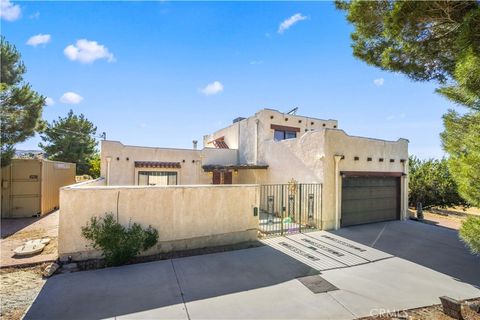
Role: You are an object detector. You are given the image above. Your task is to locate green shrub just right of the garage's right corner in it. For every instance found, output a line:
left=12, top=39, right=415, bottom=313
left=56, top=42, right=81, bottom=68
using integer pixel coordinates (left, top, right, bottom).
left=408, top=156, right=468, bottom=207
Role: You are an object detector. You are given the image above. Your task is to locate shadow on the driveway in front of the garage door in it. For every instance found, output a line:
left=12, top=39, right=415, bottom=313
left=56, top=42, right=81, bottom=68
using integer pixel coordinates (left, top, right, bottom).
left=332, top=220, right=480, bottom=288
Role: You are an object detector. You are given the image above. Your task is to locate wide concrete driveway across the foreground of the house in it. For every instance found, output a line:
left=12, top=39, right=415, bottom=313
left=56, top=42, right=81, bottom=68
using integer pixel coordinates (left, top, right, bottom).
left=25, top=222, right=480, bottom=319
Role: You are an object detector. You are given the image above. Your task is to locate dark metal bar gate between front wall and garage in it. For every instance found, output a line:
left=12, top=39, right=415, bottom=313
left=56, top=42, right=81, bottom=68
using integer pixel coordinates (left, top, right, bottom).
left=259, top=180, right=322, bottom=235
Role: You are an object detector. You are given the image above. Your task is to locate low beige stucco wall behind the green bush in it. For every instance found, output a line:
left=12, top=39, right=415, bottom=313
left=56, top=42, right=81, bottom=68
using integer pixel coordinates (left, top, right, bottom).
left=58, top=185, right=259, bottom=259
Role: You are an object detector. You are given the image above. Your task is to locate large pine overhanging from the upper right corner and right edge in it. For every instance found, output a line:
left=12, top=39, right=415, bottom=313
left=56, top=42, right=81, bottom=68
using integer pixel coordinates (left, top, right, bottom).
left=336, top=1, right=480, bottom=206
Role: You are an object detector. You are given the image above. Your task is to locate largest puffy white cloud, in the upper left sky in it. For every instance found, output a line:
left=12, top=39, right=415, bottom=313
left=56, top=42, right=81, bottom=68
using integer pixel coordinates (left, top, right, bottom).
left=63, top=39, right=115, bottom=63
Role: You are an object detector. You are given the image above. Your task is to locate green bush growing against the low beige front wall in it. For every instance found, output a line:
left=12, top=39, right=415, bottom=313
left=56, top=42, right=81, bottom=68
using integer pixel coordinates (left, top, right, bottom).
left=82, top=213, right=158, bottom=266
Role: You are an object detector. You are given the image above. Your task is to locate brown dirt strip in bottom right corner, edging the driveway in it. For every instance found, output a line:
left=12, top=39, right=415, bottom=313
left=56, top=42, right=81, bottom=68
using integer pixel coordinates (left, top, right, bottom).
left=361, top=298, right=480, bottom=320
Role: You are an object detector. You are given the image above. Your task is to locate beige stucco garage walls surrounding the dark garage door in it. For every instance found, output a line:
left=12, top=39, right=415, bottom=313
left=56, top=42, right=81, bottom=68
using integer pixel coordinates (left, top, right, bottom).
left=248, top=129, right=408, bottom=229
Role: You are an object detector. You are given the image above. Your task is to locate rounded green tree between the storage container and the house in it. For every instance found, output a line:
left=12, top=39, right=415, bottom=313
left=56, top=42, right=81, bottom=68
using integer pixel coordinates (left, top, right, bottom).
left=39, top=110, right=97, bottom=174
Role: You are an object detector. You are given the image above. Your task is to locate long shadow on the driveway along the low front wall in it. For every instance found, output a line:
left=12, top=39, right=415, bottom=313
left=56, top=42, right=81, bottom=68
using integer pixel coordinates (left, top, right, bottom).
left=25, top=246, right=318, bottom=319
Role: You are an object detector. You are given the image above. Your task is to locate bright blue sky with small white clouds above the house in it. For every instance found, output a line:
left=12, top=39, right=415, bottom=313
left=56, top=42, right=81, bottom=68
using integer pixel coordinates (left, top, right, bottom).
left=1, top=0, right=455, bottom=158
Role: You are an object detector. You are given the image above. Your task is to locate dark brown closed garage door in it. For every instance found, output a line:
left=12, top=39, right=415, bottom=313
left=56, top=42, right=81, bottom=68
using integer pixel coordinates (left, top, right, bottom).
left=341, top=176, right=400, bottom=227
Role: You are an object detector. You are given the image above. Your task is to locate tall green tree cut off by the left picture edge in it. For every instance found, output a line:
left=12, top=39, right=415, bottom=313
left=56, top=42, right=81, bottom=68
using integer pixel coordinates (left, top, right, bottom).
left=0, top=37, right=45, bottom=166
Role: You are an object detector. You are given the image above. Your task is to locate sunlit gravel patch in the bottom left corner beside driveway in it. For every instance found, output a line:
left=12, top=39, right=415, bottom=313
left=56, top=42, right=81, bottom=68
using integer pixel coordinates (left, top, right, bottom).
left=0, top=265, right=46, bottom=320
